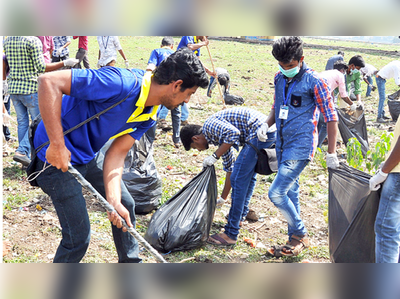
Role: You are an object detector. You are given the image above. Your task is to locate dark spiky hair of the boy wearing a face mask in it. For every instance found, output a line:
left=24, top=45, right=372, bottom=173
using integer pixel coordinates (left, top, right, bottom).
left=272, top=36, right=303, bottom=63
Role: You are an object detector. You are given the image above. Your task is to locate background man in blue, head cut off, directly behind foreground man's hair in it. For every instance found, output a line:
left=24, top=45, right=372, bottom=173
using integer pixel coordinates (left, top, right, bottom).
left=177, top=36, right=217, bottom=126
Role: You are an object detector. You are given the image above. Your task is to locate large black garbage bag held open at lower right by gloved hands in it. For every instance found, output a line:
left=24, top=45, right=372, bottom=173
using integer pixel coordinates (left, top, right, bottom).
left=328, top=163, right=380, bottom=263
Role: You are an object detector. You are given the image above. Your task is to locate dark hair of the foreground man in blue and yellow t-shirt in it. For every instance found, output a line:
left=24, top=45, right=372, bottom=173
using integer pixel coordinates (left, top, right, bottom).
left=153, top=47, right=209, bottom=91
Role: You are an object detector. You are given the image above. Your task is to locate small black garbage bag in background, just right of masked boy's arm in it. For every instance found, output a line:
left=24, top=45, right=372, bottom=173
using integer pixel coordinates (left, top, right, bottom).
left=337, top=108, right=369, bottom=156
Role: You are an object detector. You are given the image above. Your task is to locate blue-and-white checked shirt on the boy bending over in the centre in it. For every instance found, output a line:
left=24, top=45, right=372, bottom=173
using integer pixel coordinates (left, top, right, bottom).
left=202, top=107, right=267, bottom=172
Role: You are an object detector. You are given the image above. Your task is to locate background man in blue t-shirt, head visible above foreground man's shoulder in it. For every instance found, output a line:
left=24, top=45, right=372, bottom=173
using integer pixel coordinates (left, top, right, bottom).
left=146, top=36, right=181, bottom=148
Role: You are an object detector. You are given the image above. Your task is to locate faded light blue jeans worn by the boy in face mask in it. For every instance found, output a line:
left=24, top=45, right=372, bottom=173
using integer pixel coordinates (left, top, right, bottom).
left=268, top=160, right=310, bottom=240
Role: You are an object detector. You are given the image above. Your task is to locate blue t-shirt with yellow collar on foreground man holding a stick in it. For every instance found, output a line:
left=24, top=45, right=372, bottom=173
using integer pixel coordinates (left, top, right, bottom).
left=34, top=67, right=158, bottom=165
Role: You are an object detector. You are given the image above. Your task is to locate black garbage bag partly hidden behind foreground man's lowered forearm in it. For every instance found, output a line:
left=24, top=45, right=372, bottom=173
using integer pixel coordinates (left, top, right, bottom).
left=98, top=134, right=162, bottom=214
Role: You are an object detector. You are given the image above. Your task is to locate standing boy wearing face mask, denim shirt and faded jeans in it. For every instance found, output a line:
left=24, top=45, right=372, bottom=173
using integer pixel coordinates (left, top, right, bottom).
left=258, top=37, right=339, bottom=257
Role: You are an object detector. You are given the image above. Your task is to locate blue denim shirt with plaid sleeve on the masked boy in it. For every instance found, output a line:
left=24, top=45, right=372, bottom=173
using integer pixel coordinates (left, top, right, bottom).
left=273, top=62, right=338, bottom=163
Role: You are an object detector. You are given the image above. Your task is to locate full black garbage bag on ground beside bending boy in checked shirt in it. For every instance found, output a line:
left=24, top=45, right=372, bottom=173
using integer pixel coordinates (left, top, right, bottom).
left=144, top=166, right=217, bottom=252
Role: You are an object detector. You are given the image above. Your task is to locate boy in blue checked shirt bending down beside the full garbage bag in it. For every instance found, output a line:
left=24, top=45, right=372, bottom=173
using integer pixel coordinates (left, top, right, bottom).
left=181, top=107, right=275, bottom=246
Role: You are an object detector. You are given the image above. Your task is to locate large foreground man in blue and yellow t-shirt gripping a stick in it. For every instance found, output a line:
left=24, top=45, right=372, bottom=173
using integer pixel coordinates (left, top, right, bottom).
left=34, top=49, right=209, bottom=262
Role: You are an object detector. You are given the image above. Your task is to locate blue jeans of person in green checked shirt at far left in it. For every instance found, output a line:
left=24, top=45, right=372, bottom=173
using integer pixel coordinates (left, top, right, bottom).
left=10, top=93, right=39, bottom=157
